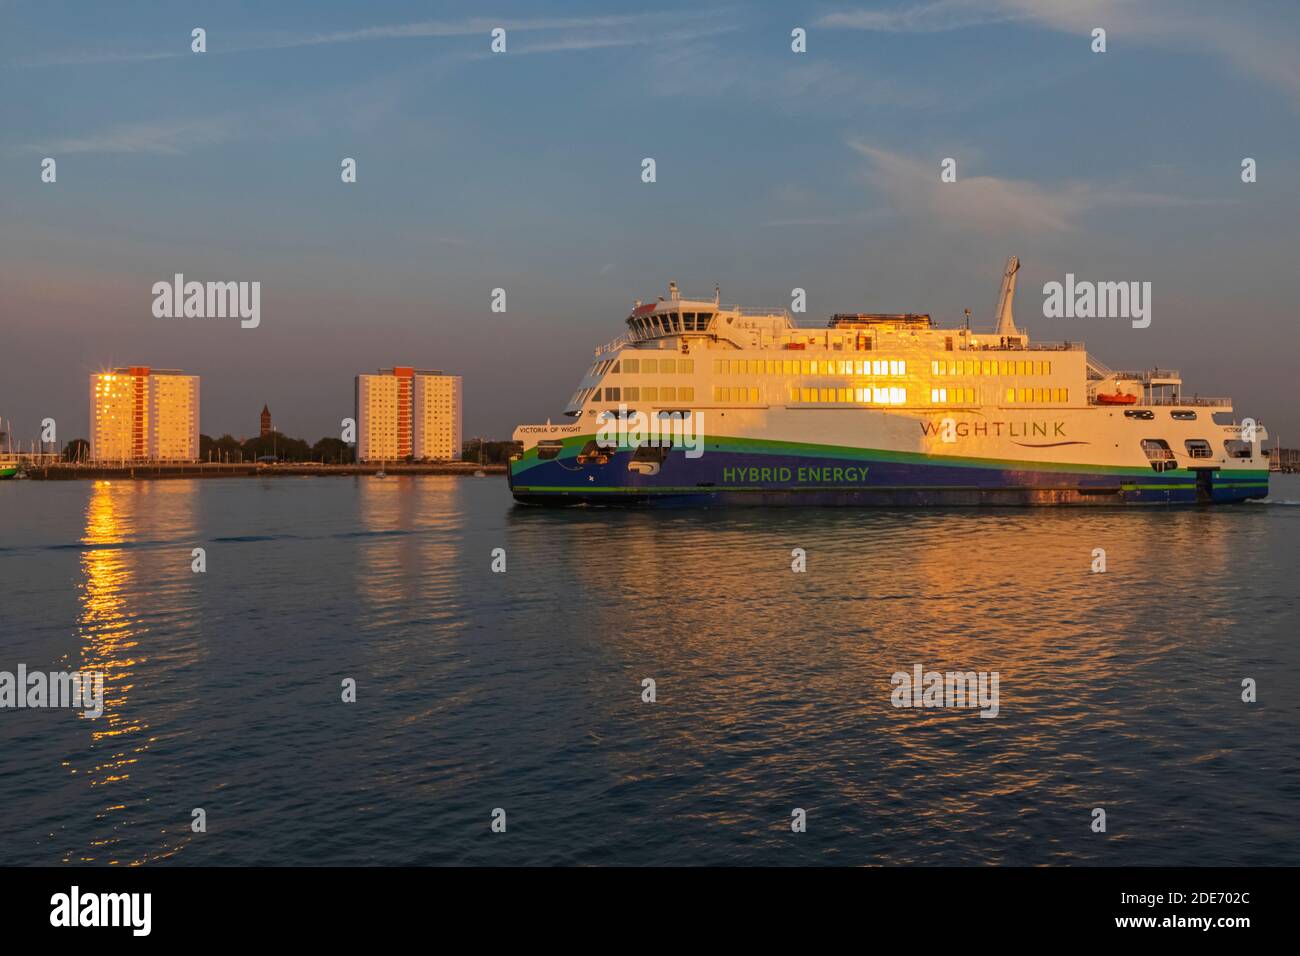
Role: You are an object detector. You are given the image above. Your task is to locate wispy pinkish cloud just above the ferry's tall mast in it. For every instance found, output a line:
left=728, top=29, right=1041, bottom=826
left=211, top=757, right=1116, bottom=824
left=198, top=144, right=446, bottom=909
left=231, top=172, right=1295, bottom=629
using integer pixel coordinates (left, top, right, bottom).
left=849, top=140, right=1223, bottom=235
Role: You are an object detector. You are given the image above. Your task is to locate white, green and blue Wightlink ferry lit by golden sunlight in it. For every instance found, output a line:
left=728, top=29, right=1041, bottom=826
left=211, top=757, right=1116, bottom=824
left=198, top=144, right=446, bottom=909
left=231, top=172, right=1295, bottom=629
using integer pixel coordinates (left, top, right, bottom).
left=508, top=256, right=1269, bottom=506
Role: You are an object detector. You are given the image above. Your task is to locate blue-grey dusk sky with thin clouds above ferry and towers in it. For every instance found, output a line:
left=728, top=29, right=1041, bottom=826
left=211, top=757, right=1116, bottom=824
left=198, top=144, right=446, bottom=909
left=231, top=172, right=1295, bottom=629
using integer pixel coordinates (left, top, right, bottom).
left=0, top=0, right=1300, bottom=444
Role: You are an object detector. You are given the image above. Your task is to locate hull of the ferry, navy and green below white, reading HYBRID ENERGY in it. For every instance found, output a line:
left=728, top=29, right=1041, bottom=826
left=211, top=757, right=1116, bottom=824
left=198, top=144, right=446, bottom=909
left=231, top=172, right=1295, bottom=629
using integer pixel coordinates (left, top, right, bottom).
left=510, top=408, right=1269, bottom=507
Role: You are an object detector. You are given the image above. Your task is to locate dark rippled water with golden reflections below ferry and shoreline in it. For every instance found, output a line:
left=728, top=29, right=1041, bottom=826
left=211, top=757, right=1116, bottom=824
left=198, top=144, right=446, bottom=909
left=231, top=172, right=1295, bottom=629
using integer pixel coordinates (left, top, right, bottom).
left=0, top=476, right=1300, bottom=865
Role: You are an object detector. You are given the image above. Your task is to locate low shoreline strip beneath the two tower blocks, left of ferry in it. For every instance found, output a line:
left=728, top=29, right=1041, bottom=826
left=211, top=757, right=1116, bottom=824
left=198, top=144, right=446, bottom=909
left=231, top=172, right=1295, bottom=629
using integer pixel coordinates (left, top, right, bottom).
left=10, top=462, right=506, bottom=481
